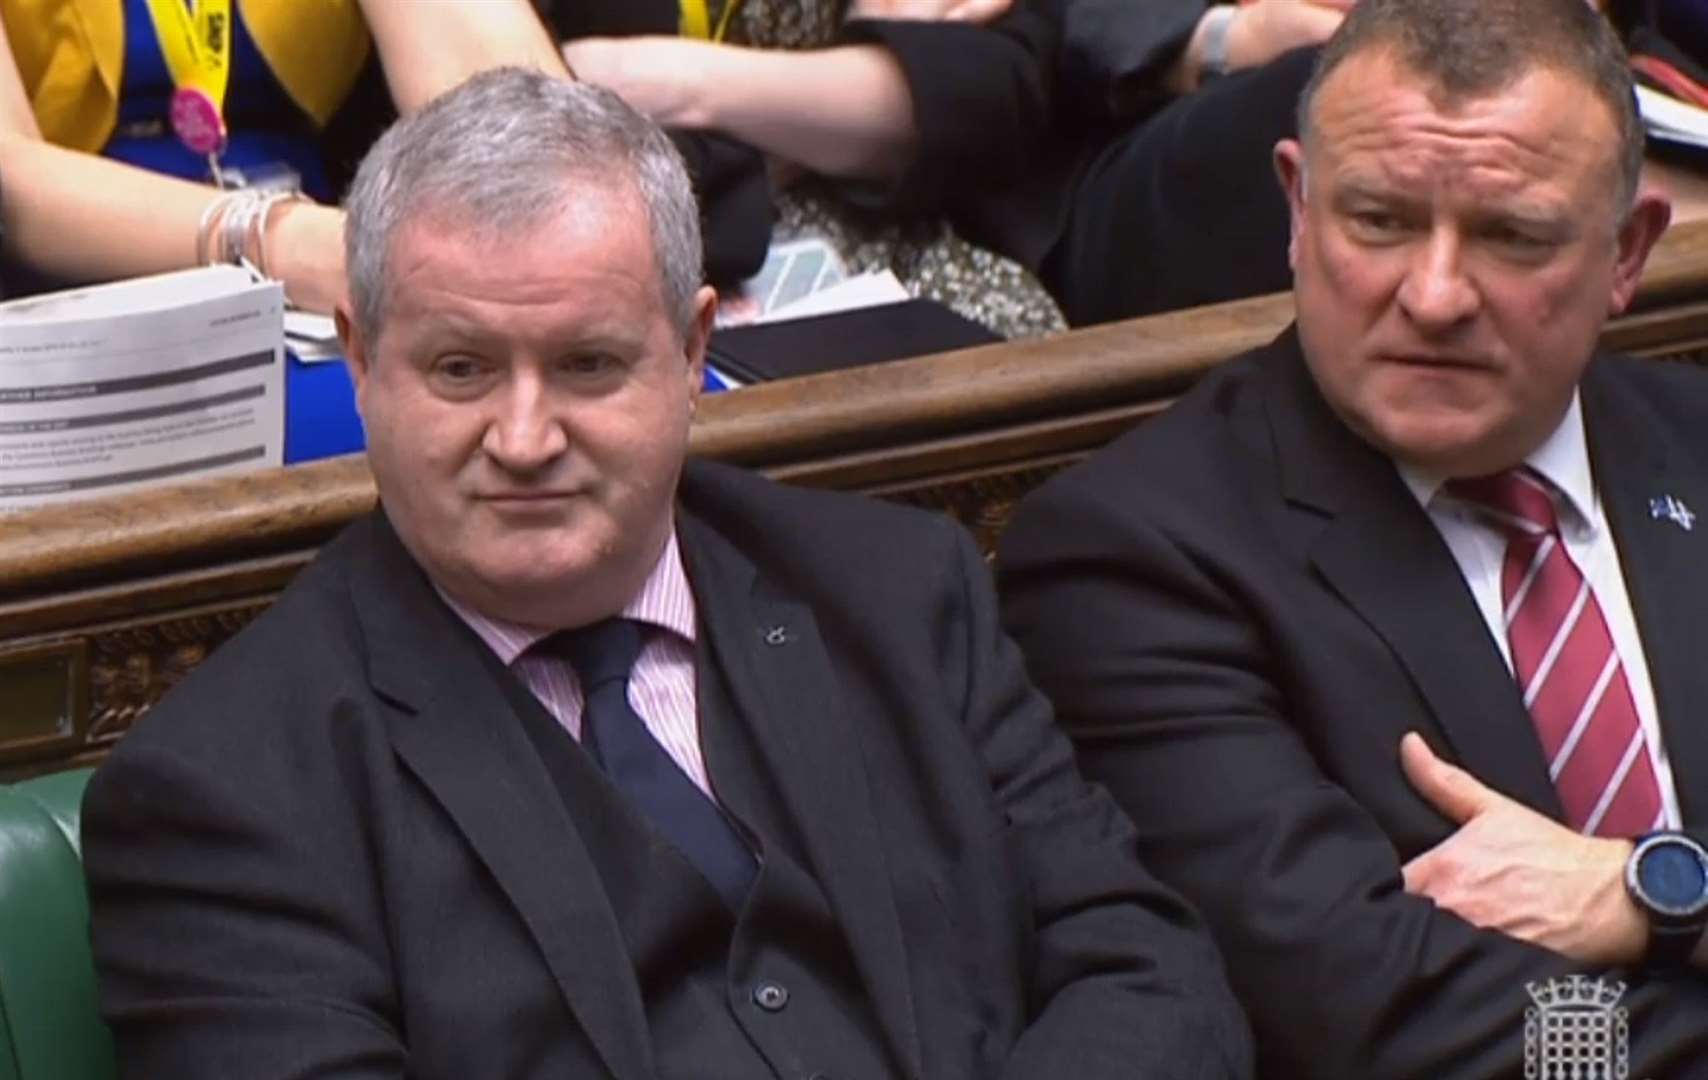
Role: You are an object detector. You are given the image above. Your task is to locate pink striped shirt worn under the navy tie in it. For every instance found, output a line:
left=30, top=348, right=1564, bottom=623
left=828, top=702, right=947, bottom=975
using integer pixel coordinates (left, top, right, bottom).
left=439, top=533, right=712, bottom=795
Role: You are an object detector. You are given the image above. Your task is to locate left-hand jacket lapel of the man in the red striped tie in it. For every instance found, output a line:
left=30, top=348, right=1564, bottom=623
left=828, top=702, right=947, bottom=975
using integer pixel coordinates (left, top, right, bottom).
left=1264, top=335, right=1561, bottom=819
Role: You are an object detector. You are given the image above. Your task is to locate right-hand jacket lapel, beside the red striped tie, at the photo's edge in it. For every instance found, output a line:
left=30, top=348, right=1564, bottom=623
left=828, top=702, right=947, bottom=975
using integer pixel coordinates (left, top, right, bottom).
left=1582, top=359, right=1708, bottom=827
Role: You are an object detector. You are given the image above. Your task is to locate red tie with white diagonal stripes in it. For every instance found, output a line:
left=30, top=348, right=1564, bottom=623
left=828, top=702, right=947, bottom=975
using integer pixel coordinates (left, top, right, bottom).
left=1447, top=468, right=1662, bottom=836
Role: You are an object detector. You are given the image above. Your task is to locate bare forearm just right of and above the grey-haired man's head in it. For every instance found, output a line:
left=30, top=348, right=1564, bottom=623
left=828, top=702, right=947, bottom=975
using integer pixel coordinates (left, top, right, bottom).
left=564, top=38, right=917, bottom=179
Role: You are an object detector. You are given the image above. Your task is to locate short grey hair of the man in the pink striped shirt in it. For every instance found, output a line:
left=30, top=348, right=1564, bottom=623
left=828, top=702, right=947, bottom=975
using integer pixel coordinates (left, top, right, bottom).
left=343, top=67, right=702, bottom=343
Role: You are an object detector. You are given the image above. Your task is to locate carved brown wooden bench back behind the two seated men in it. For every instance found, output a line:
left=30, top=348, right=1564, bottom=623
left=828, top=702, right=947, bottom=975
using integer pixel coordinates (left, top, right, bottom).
left=0, top=222, right=1708, bottom=779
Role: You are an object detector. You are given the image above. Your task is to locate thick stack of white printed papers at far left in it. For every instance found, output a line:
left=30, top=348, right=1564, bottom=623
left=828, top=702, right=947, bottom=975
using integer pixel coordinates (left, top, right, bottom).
left=0, top=267, right=285, bottom=511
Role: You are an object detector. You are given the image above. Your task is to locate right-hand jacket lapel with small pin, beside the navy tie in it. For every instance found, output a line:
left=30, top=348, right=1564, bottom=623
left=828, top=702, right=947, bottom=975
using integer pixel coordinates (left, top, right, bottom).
left=680, top=514, right=921, bottom=1075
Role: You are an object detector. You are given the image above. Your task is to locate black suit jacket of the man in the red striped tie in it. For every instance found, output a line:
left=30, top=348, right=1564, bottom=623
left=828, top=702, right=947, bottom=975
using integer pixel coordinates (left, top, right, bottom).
left=1001, top=332, right=1708, bottom=1080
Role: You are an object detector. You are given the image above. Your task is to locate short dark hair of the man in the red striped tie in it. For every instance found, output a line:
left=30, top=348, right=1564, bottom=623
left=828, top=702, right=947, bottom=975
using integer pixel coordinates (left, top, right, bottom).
left=1298, top=0, right=1643, bottom=208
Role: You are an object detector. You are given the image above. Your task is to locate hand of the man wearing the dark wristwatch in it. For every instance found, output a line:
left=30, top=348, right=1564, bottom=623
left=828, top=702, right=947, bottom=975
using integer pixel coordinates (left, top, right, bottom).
left=1399, top=731, right=1648, bottom=966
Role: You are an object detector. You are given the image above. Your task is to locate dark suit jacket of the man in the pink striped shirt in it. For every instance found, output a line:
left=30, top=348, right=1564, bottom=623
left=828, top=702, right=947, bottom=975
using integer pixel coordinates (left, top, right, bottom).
left=84, top=463, right=1249, bottom=1080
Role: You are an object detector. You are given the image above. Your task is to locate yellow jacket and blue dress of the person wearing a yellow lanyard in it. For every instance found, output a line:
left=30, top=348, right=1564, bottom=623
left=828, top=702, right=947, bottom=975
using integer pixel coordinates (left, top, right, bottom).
left=0, top=0, right=371, bottom=461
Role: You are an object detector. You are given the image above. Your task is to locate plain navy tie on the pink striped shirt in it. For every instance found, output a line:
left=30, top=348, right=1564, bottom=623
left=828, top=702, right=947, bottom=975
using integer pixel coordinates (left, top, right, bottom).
left=545, top=619, right=757, bottom=911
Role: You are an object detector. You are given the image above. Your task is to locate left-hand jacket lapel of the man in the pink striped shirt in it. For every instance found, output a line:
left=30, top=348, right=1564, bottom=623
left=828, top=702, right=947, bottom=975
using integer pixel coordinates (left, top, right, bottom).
left=352, top=514, right=652, bottom=1080
